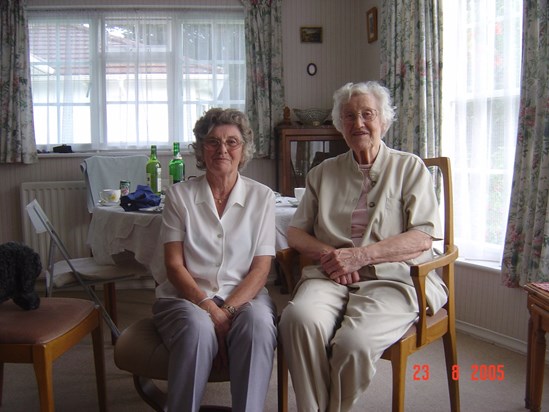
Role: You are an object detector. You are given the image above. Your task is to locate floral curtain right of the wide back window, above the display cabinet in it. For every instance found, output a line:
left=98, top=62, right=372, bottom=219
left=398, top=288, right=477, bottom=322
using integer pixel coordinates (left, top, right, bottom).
left=241, top=0, right=284, bottom=158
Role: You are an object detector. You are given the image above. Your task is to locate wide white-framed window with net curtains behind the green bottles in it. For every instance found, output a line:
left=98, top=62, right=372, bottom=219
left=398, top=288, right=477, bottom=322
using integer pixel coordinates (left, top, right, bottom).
left=29, top=9, right=246, bottom=150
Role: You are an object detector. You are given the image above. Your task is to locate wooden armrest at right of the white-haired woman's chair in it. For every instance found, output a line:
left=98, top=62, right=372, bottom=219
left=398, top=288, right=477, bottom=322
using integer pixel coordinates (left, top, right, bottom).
left=410, top=245, right=458, bottom=346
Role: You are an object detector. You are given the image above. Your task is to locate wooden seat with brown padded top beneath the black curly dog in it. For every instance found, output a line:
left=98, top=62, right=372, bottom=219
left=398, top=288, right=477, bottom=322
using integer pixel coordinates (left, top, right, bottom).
left=0, top=298, right=107, bottom=411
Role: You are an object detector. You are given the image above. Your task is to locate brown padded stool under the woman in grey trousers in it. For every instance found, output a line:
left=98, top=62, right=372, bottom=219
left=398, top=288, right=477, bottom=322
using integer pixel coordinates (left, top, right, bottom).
left=114, top=319, right=231, bottom=412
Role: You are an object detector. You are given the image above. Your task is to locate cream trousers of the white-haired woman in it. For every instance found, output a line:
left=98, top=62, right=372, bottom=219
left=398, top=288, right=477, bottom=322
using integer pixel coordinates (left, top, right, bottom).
left=279, top=278, right=418, bottom=412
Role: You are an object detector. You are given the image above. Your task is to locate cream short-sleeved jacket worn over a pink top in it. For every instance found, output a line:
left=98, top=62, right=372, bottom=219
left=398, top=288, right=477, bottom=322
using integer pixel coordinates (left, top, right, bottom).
left=290, top=142, right=447, bottom=313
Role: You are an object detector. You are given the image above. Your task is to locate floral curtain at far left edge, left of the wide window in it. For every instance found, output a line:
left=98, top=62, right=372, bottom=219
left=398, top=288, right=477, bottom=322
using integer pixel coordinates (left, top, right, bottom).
left=0, top=0, right=38, bottom=164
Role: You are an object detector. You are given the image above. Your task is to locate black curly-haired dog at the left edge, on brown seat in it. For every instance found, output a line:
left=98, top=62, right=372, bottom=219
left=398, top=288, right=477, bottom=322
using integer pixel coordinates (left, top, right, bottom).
left=0, top=242, right=42, bottom=310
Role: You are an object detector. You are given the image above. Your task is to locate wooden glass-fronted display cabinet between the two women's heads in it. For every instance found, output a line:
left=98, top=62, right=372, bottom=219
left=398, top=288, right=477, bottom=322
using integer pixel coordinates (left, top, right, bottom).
left=275, top=124, right=349, bottom=196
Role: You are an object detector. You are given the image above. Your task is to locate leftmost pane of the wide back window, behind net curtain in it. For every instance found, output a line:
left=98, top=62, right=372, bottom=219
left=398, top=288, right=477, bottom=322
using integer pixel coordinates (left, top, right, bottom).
left=29, top=18, right=92, bottom=145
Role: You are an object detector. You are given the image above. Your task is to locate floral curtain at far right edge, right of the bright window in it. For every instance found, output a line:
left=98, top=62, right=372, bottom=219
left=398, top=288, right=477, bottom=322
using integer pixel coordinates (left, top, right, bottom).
left=502, top=0, right=549, bottom=287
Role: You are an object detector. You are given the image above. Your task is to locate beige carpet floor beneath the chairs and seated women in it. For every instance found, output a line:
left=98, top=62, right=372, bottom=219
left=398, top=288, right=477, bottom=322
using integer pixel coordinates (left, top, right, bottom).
left=0, top=285, right=549, bottom=412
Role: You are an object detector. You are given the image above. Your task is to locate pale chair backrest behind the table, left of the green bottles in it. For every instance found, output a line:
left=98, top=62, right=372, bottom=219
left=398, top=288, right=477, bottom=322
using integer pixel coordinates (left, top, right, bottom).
left=80, top=155, right=149, bottom=213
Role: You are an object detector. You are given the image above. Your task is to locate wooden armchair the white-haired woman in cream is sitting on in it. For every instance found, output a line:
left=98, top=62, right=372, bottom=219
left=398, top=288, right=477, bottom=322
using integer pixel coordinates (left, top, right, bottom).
left=276, top=157, right=460, bottom=412
